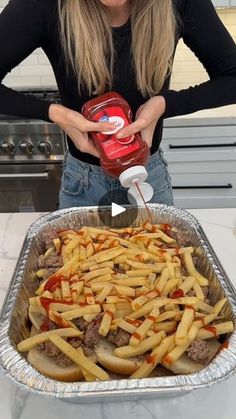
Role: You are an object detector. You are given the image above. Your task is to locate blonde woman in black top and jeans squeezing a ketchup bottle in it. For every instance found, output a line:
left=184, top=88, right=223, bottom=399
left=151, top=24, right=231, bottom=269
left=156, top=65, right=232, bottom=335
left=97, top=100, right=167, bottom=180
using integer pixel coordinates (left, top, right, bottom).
left=0, top=0, right=236, bottom=208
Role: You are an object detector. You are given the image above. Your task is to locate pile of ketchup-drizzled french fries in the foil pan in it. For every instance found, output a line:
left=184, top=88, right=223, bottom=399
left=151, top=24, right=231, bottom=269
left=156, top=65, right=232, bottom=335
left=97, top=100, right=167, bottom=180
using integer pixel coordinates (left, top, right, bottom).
left=18, top=223, right=233, bottom=381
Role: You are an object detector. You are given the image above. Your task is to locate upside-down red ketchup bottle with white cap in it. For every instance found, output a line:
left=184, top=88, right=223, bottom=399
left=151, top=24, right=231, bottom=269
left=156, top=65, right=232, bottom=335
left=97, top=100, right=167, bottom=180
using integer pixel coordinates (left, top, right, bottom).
left=82, top=92, right=153, bottom=204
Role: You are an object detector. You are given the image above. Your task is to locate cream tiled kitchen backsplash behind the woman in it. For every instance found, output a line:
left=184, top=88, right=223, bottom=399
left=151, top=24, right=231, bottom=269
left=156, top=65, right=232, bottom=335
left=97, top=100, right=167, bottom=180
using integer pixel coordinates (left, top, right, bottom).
left=0, top=0, right=236, bottom=90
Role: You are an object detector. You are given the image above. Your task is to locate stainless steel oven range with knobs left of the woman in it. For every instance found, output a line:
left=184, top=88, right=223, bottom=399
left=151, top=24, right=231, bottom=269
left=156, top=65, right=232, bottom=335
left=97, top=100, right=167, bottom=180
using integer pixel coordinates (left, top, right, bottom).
left=0, top=91, right=66, bottom=212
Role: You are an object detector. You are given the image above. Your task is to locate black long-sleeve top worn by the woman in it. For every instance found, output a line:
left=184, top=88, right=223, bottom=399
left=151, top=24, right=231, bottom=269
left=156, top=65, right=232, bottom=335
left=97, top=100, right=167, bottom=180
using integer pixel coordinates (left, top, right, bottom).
left=0, top=0, right=236, bottom=164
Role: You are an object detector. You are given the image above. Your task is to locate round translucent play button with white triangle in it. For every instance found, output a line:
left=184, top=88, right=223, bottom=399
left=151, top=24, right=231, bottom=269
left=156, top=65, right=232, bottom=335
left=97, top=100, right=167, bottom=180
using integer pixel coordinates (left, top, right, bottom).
left=98, top=189, right=138, bottom=228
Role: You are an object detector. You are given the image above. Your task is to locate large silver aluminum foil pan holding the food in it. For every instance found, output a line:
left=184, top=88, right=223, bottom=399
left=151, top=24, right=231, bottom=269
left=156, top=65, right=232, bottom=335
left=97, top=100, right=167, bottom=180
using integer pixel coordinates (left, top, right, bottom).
left=0, top=204, right=236, bottom=402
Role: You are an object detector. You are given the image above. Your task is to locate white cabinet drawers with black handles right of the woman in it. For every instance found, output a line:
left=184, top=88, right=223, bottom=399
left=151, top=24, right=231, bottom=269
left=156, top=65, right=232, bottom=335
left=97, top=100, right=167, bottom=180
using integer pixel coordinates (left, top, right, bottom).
left=161, top=118, right=236, bottom=208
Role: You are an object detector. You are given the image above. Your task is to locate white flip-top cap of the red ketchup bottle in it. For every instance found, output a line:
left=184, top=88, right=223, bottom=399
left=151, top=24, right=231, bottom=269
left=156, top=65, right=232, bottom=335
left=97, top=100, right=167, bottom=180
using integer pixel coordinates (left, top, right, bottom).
left=119, top=166, right=154, bottom=205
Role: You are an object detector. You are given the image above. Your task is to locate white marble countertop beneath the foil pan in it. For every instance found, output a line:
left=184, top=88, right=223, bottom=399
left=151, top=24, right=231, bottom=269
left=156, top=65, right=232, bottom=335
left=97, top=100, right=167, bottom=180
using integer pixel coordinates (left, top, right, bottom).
left=0, top=208, right=236, bottom=419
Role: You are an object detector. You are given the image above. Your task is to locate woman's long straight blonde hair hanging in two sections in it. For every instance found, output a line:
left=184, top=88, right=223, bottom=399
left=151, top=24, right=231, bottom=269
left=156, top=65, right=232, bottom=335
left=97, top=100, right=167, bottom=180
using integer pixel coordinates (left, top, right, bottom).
left=58, top=0, right=176, bottom=96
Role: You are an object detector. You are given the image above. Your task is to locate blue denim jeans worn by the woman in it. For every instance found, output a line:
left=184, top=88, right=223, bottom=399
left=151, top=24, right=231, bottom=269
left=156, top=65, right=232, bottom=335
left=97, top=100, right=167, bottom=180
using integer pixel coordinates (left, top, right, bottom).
left=60, top=151, right=173, bottom=209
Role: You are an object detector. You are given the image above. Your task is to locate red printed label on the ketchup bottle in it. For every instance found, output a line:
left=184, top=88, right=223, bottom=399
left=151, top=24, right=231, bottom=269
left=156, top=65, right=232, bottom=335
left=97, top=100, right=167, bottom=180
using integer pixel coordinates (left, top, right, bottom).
left=93, top=107, right=139, bottom=160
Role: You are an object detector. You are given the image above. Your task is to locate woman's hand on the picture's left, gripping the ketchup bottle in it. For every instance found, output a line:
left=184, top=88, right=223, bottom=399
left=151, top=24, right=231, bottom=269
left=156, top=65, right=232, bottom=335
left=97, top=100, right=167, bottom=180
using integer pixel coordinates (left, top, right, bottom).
left=49, top=103, right=115, bottom=157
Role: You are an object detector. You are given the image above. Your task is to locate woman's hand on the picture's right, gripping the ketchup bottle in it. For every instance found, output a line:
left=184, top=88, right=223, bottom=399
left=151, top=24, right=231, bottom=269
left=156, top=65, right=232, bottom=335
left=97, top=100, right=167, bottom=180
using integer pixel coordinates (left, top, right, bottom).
left=116, top=96, right=166, bottom=148
